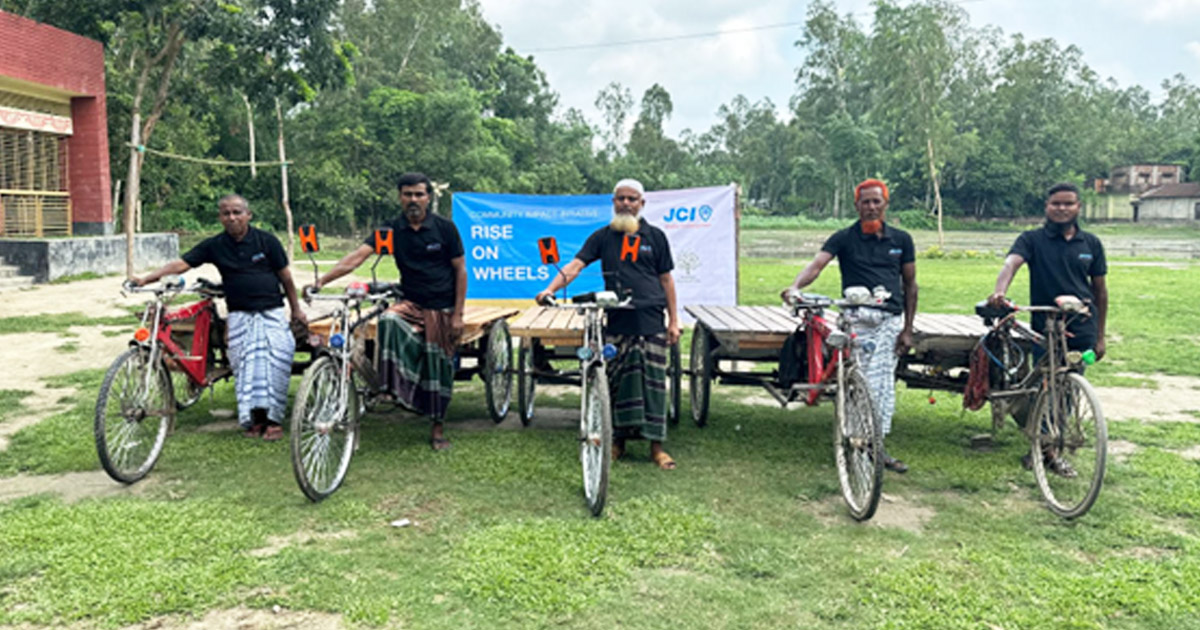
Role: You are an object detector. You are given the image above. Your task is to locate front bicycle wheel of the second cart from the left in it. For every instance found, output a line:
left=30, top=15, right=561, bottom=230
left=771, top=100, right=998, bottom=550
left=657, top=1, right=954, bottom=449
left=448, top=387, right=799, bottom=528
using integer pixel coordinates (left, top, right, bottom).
left=290, top=356, right=359, bottom=502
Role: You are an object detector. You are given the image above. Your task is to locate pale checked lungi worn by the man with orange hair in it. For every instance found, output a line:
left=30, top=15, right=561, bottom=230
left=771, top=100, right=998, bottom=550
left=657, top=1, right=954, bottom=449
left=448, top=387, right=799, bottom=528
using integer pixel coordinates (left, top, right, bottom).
left=846, top=308, right=904, bottom=436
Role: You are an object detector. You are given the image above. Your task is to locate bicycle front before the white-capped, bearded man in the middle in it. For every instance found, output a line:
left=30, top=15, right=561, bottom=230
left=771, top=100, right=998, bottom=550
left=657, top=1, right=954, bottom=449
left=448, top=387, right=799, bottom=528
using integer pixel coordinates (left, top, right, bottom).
left=542, top=290, right=631, bottom=516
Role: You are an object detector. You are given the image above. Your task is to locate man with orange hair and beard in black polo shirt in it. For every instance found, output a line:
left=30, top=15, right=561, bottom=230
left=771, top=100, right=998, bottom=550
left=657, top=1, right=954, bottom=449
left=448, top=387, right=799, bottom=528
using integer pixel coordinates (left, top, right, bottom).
left=782, top=179, right=917, bottom=473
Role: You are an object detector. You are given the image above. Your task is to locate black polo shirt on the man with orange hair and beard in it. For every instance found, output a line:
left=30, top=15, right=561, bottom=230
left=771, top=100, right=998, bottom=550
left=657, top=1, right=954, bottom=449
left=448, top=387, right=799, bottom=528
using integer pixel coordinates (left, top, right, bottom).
left=821, top=221, right=917, bottom=313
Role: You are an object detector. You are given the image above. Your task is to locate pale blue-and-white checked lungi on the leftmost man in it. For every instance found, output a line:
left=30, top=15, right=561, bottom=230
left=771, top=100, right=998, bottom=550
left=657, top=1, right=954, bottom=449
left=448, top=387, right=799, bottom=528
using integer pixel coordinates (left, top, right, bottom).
left=228, top=306, right=296, bottom=427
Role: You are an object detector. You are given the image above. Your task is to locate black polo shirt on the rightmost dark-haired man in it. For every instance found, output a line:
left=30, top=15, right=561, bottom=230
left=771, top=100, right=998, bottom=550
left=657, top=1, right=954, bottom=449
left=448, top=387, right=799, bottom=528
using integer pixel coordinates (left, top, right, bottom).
left=1008, top=226, right=1109, bottom=349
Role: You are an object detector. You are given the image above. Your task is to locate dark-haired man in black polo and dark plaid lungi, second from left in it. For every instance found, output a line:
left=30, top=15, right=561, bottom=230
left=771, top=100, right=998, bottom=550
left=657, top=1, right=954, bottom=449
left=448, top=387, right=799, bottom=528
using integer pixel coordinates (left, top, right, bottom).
left=316, top=173, right=467, bottom=450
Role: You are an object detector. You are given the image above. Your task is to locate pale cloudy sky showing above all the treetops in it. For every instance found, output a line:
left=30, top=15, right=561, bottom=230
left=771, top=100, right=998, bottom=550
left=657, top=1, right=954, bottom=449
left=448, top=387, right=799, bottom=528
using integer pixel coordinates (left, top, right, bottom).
left=480, top=0, right=1200, bottom=136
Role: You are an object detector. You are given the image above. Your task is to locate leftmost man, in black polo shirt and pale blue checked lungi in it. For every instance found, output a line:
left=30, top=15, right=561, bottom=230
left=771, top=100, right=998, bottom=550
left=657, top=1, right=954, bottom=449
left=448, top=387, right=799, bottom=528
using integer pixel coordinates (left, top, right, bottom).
left=131, top=194, right=306, bottom=442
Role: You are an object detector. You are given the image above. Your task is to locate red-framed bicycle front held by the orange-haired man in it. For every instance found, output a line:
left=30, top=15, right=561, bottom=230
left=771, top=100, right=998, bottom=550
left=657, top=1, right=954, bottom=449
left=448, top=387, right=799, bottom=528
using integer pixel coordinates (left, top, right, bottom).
left=785, top=287, right=883, bottom=521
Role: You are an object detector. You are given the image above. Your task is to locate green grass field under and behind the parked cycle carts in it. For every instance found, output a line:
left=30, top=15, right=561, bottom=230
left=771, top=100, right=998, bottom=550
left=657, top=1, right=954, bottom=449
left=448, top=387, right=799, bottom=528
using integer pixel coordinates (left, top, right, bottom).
left=0, top=254, right=1200, bottom=630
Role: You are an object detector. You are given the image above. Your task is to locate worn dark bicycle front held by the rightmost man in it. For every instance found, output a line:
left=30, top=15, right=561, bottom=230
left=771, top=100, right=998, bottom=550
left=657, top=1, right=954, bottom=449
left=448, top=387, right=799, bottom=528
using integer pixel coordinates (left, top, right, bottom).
left=968, top=295, right=1108, bottom=518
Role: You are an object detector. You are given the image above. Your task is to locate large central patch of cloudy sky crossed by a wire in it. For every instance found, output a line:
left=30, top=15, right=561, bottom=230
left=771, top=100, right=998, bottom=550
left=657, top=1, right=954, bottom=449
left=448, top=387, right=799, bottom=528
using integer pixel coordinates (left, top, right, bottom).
left=480, top=0, right=804, bottom=136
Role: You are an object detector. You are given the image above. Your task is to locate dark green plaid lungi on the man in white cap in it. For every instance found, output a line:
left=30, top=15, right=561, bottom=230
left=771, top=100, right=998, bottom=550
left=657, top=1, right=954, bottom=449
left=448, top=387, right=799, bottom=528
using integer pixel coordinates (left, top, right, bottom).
left=605, top=335, right=667, bottom=442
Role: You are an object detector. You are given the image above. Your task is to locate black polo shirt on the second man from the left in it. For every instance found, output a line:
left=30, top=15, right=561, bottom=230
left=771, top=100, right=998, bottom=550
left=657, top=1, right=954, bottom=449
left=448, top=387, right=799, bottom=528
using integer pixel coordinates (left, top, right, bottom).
left=362, top=212, right=463, bottom=308
